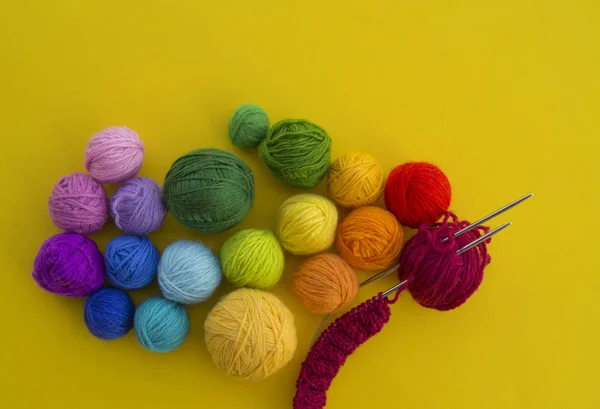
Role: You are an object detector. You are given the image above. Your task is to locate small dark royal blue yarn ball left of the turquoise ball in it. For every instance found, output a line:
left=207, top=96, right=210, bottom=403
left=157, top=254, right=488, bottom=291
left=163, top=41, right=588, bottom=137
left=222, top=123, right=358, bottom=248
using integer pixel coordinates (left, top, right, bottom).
left=83, top=288, right=135, bottom=340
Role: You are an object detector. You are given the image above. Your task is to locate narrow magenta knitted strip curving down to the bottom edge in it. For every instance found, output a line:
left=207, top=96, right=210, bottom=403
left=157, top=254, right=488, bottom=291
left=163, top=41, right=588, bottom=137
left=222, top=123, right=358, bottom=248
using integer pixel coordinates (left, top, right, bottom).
left=294, top=294, right=391, bottom=409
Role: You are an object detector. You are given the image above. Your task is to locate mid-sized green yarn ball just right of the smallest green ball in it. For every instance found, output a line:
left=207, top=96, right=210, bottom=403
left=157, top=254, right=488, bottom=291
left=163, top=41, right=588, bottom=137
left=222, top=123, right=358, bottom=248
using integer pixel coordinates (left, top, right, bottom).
left=258, top=119, right=331, bottom=187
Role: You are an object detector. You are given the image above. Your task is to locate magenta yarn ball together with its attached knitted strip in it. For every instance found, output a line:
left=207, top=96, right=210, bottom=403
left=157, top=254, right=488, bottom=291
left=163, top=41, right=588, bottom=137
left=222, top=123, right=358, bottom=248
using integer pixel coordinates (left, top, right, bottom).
left=294, top=212, right=491, bottom=409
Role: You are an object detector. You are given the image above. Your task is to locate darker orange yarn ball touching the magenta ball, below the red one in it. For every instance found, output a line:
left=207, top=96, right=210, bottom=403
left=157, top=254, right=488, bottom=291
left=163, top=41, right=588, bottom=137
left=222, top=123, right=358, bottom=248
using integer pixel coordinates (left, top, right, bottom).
left=335, top=206, right=404, bottom=271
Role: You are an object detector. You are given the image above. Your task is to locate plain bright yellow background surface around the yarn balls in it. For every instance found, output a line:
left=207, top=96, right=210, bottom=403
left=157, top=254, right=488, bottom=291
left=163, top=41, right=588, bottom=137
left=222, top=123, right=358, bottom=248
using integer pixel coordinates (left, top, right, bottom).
left=0, top=0, right=600, bottom=409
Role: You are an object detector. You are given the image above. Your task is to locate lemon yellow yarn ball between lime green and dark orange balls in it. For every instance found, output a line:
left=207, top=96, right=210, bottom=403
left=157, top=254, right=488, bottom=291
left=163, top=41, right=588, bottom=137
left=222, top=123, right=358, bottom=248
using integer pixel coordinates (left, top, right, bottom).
left=277, top=194, right=338, bottom=255
